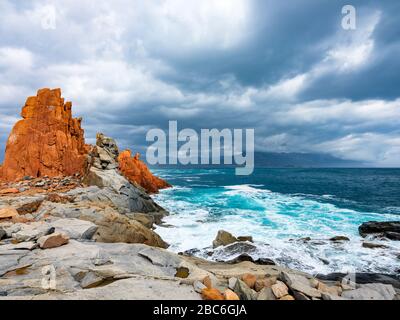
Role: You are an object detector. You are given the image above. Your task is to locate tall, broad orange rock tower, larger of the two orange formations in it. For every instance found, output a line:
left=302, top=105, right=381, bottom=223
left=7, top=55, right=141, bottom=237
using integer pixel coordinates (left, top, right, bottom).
left=0, top=89, right=88, bottom=181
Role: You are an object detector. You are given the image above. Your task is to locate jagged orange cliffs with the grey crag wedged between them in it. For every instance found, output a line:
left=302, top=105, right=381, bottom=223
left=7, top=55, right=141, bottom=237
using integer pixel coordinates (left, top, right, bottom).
left=0, top=89, right=170, bottom=193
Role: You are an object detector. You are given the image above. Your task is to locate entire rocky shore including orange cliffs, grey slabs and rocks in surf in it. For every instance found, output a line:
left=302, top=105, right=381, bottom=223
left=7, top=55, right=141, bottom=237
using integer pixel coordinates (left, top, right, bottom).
left=0, top=89, right=400, bottom=300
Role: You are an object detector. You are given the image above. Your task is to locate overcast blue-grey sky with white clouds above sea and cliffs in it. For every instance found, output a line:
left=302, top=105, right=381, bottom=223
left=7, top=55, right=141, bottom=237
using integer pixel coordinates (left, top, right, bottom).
left=0, top=0, right=400, bottom=166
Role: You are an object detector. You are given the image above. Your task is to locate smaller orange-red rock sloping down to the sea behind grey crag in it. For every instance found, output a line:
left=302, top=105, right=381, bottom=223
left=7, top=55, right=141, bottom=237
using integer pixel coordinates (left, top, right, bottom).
left=118, top=150, right=171, bottom=193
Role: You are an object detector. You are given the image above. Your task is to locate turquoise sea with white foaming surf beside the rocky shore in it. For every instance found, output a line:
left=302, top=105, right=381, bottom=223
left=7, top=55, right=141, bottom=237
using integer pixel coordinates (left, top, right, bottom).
left=154, top=168, right=400, bottom=274
